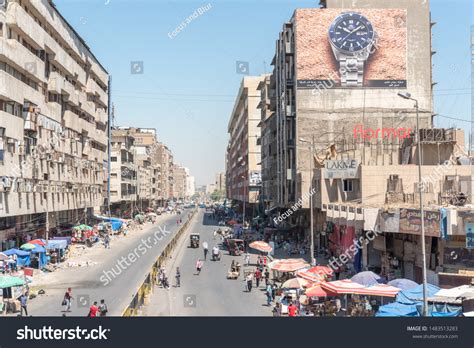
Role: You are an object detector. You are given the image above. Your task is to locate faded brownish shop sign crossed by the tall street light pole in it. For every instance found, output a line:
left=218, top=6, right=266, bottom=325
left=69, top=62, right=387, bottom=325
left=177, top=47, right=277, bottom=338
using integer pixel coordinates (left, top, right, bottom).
left=399, top=209, right=441, bottom=237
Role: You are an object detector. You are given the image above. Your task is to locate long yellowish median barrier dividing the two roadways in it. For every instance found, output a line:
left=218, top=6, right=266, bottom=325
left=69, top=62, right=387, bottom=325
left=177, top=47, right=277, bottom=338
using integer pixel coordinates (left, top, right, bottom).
left=122, top=209, right=197, bottom=317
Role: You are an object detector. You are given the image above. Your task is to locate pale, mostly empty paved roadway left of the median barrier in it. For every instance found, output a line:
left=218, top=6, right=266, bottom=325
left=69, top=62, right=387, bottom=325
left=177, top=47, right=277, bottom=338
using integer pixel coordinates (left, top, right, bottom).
left=23, top=211, right=194, bottom=317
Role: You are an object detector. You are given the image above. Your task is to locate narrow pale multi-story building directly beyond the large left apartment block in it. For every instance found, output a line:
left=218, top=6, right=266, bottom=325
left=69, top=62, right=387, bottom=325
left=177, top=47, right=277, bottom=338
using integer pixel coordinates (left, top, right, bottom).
left=110, top=129, right=138, bottom=216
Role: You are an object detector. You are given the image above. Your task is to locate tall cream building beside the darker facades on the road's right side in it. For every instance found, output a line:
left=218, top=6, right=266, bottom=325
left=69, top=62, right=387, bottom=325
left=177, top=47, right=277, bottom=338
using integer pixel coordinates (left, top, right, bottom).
left=226, top=75, right=267, bottom=215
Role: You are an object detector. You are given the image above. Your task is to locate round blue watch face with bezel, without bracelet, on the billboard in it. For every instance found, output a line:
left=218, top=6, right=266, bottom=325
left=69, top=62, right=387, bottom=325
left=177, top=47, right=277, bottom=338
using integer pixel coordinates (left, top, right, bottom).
left=329, top=12, right=375, bottom=53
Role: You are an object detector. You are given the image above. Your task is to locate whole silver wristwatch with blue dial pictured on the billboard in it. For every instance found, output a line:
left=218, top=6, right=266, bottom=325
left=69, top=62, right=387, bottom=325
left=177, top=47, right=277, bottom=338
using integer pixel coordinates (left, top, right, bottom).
left=329, top=12, right=377, bottom=87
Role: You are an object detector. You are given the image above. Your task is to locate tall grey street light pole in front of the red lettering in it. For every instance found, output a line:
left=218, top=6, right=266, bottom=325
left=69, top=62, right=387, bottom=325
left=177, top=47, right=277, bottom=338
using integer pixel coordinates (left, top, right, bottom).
left=398, top=92, right=428, bottom=317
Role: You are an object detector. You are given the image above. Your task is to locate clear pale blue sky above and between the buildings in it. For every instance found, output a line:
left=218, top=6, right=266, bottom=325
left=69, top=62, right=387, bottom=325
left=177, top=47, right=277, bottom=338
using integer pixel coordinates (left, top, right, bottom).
left=55, top=0, right=474, bottom=185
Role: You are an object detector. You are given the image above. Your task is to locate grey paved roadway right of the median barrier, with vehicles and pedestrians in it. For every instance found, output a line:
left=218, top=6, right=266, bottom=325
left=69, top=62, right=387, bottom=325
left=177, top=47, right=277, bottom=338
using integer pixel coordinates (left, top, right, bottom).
left=142, top=209, right=271, bottom=316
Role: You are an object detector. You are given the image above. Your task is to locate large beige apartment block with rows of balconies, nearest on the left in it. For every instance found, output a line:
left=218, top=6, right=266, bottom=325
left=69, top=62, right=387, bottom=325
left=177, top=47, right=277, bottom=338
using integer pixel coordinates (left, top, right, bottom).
left=0, top=0, right=109, bottom=243
